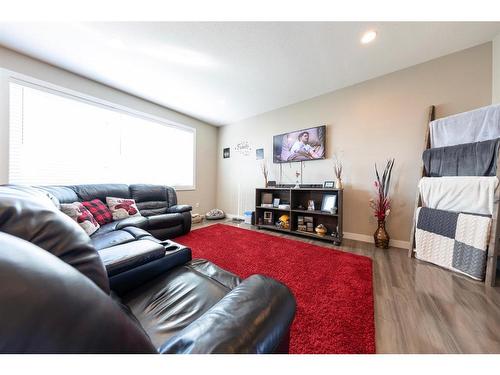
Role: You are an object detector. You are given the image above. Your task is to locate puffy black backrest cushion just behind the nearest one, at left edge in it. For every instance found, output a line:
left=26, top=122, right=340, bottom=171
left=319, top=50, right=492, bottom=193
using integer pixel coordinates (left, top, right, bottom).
left=0, top=186, right=109, bottom=293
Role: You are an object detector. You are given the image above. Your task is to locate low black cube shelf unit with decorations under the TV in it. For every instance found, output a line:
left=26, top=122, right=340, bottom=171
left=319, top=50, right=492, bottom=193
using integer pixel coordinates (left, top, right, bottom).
left=255, top=188, right=343, bottom=245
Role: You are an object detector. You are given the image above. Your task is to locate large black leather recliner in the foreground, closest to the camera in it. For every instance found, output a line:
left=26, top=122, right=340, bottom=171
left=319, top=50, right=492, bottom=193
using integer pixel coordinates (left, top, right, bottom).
left=0, top=187, right=295, bottom=353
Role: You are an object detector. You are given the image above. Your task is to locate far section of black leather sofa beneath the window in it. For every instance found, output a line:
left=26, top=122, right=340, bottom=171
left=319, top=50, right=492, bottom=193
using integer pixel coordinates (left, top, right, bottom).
left=36, top=184, right=192, bottom=244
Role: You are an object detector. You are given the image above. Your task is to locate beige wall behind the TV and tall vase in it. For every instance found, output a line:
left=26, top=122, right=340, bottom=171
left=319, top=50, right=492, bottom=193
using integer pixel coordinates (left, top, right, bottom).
left=217, top=43, right=492, bottom=246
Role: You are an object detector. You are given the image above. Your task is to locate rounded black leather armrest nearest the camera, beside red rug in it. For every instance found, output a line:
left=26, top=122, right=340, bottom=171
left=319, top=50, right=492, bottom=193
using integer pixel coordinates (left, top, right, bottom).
left=159, top=275, right=296, bottom=353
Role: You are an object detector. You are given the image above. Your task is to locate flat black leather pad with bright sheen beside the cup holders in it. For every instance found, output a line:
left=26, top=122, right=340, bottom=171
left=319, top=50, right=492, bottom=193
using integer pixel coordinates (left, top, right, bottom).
left=99, top=239, right=165, bottom=276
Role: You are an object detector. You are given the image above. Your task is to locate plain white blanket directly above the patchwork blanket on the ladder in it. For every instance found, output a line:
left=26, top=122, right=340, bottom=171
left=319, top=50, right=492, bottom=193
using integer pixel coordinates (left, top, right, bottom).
left=418, top=176, right=498, bottom=216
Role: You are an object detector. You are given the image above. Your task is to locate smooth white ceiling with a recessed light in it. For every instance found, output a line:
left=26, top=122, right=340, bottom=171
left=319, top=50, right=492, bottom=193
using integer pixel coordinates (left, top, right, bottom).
left=0, top=22, right=500, bottom=125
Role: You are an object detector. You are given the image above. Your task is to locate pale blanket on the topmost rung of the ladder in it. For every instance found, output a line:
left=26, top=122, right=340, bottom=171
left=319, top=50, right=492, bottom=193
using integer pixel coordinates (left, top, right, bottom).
left=429, top=104, right=500, bottom=148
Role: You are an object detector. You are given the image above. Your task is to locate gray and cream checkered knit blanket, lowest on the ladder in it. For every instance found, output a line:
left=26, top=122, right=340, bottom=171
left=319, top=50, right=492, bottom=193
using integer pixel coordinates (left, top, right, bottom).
left=415, top=207, right=491, bottom=280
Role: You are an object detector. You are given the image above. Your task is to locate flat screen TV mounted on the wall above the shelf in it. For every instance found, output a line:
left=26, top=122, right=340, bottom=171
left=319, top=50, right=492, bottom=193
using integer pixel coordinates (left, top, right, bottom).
left=273, top=125, right=326, bottom=163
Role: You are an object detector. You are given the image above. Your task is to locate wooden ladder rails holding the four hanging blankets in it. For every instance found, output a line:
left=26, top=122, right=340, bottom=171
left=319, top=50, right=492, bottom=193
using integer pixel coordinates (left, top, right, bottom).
left=408, top=106, right=500, bottom=286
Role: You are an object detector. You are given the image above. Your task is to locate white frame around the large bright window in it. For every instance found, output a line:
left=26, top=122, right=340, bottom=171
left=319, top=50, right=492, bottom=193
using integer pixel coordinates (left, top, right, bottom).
left=8, top=72, right=197, bottom=191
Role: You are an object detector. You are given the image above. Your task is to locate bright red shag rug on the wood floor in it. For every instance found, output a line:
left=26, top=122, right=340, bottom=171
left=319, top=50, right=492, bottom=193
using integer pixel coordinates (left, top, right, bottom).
left=175, top=224, right=375, bottom=354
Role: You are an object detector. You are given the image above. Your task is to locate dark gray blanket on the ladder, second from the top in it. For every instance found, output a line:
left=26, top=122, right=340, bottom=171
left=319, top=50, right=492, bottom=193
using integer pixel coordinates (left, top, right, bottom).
left=422, top=138, right=500, bottom=177
